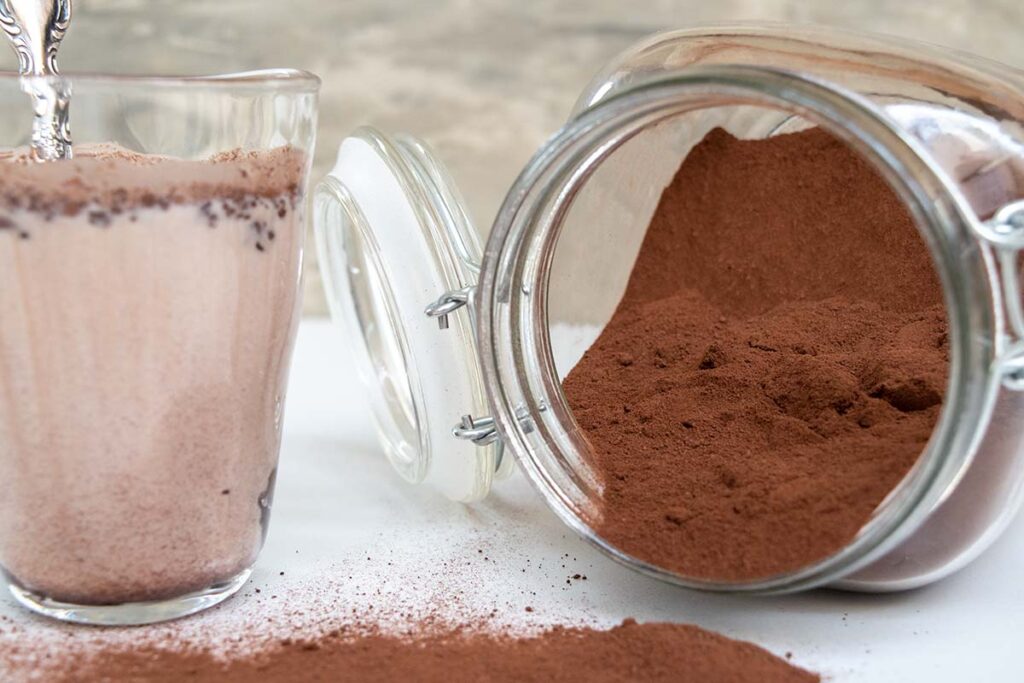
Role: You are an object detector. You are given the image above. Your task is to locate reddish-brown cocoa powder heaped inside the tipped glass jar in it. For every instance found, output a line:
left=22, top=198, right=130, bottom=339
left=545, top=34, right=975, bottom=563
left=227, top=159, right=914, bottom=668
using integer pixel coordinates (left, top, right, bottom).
left=564, top=129, right=948, bottom=581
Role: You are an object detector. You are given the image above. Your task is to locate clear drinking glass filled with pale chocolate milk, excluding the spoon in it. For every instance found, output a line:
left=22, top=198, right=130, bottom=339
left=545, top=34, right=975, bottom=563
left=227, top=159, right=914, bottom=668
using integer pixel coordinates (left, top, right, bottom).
left=0, top=70, right=318, bottom=625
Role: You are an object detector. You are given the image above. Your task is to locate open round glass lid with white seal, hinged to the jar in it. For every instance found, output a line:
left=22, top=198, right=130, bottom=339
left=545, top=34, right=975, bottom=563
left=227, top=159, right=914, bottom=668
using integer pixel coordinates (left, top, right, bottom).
left=313, top=128, right=512, bottom=502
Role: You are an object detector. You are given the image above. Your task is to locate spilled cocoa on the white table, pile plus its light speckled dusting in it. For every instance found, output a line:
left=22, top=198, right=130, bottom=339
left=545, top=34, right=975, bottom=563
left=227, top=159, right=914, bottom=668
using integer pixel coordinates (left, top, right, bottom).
left=0, top=505, right=816, bottom=683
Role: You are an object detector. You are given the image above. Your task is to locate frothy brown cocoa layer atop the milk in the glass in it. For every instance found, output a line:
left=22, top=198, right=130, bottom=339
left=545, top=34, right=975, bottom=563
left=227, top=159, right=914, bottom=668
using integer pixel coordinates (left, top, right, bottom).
left=0, top=144, right=306, bottom=215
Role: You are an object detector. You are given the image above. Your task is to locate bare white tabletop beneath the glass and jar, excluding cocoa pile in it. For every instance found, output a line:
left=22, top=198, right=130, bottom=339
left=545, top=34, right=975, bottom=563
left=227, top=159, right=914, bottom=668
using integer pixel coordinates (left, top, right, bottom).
left=0, top=322, right=1024, bottom=683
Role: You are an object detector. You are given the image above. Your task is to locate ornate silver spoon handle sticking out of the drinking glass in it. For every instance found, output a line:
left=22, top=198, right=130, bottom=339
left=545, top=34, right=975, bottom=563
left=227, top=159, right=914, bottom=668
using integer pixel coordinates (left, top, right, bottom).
left=0, top=0, right=72, bottom=161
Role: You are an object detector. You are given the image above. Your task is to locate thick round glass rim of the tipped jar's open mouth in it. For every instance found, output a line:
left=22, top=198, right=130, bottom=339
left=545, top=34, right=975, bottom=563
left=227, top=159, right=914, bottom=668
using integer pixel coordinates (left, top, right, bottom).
left=477, top=66, right=997, bottom=593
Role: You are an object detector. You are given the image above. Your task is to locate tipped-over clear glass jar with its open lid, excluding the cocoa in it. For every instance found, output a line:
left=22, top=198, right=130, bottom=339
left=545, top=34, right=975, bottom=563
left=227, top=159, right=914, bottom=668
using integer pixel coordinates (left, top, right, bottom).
left=314, top=26, right=1024, bottom=593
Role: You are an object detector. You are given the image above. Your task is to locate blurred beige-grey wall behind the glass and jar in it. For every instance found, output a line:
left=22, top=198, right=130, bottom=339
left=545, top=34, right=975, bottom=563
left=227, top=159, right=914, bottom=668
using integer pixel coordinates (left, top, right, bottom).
left=19, top=0, right=1024, bottom=314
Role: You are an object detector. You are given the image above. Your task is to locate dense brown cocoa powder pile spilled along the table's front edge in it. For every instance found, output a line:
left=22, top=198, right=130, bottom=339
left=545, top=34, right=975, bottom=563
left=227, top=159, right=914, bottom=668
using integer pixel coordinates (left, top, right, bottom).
left=44, top=620, right=820, bottom=683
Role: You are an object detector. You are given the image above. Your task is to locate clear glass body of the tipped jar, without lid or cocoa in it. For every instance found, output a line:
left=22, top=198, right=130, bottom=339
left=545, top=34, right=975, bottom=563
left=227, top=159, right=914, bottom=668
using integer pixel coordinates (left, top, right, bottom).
left=481, top=30, right=1024, bottom=591
